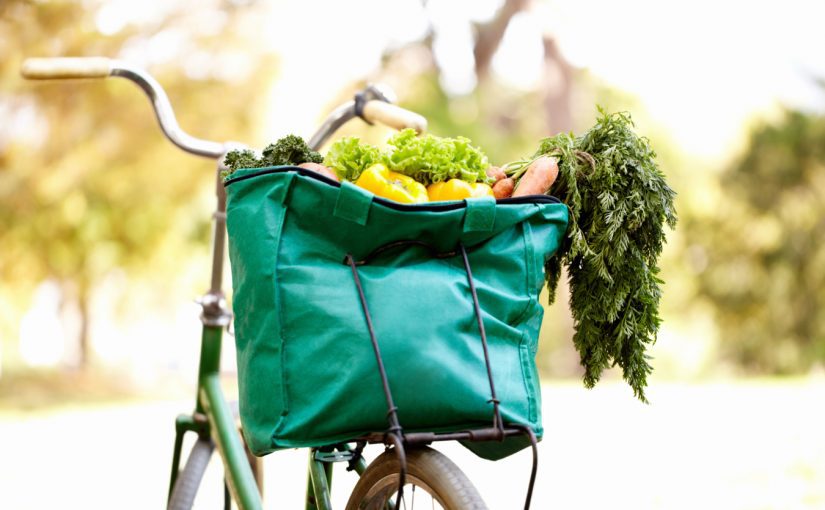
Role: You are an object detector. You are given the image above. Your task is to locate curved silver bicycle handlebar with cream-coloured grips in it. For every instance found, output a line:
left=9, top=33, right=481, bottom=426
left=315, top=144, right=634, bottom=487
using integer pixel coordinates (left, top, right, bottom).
left=20, top=57, right=427, bottom=159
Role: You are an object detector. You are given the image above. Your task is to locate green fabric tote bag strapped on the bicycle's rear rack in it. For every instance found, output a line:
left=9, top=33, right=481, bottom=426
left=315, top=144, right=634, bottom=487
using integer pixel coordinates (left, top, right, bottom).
left=225, top=167, right=567, bottom=459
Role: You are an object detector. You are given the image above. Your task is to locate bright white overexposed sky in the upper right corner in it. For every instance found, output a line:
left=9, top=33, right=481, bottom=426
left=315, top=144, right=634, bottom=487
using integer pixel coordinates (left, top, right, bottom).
left=535, top=0, right=825, bottom=157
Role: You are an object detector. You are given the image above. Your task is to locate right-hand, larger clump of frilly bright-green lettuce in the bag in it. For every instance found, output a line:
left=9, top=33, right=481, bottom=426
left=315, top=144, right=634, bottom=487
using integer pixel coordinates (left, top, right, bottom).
left=387, top=129, right=491, bottom=186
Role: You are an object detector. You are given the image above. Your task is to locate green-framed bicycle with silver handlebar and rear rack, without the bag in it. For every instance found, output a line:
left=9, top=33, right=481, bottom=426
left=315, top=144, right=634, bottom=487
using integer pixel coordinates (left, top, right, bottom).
left=21, top=57, right=537, bottom=510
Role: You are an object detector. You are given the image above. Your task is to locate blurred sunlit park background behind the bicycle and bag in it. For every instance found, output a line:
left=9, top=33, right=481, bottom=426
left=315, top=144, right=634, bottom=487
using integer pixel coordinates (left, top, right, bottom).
left=0, top=0, right=825, bottom=509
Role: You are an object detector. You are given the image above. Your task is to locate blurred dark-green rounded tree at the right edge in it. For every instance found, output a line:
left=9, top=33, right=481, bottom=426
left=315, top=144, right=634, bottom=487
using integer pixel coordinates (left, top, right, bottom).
left=685, top=111, right=825, bottom=374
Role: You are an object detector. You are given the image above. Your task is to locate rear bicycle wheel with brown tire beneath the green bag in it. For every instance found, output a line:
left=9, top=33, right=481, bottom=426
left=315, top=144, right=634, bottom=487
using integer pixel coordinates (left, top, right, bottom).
left=347, top=447, right=487, bottom=510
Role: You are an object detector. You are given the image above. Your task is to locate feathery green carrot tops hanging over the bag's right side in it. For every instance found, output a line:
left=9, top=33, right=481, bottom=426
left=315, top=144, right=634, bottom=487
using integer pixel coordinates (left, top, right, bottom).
left=536, top=109, right=676, bottom=401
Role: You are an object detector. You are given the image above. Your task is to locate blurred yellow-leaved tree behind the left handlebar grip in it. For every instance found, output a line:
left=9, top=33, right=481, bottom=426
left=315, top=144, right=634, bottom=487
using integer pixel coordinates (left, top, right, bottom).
left=0, top=0, right=274, bottom=367
